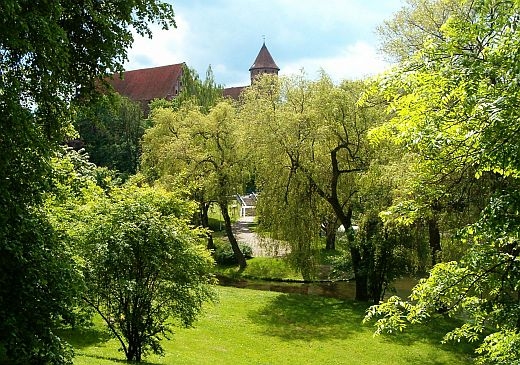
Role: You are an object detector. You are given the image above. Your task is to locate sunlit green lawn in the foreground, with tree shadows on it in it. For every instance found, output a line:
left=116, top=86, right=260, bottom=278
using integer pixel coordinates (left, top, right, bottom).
left=64, top=287, right=471, bottom=365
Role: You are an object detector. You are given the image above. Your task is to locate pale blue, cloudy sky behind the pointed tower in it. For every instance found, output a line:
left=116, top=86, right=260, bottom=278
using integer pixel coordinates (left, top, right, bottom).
left=125, top=0, right=403, bottom=87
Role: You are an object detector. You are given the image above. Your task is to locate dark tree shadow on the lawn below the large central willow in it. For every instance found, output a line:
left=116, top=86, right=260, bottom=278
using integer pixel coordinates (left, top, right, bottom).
left=250, top=294, right=368, bottom=340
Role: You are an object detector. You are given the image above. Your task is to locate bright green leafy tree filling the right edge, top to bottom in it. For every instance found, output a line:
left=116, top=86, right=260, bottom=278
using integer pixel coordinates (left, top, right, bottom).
left=367, top=0, right=520, bottom=364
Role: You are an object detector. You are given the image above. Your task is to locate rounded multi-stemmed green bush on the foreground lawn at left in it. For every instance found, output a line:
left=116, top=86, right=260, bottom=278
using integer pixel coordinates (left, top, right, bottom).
left=72, top=186, right=214, bottom=361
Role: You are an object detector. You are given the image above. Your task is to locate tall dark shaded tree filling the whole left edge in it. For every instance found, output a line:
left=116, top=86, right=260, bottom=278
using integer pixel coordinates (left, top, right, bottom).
left=0, top=0, right=175, bottom=364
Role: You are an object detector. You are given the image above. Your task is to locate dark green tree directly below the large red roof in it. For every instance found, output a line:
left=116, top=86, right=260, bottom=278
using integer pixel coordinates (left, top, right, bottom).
left=72, top=93, right=145, bottom=176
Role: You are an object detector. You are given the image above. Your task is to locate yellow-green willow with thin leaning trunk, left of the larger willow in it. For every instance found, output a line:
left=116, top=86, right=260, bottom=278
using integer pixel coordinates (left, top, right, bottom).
left=143, top=102, right=247, bottom=268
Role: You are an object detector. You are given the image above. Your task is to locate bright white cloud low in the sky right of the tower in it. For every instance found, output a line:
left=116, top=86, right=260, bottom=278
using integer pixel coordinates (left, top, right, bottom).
left=280, top=41, right=390, bottom=82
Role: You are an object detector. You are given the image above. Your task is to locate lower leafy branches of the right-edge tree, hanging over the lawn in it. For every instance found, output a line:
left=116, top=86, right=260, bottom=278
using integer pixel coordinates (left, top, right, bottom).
left=366, top=194, right=520, bottom=364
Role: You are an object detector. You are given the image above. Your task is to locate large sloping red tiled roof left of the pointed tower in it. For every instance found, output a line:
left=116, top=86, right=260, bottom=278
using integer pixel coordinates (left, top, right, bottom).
left=108, top=63, right=184, bottom=101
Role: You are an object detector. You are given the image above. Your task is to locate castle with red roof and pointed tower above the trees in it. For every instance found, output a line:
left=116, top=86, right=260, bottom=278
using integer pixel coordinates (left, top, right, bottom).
left=109, top=42, right=280, bottom=109
